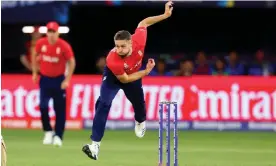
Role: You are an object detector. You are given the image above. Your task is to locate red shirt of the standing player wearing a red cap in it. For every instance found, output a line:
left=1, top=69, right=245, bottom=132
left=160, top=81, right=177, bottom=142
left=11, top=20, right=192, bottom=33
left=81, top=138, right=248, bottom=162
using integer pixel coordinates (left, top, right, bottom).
left=35, top=37, right=74, bottom=77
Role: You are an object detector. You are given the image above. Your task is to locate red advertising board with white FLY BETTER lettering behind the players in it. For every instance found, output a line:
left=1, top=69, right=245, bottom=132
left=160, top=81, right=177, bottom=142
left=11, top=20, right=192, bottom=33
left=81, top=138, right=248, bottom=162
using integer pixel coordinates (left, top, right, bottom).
left=1, top=75, right=276, bottom=130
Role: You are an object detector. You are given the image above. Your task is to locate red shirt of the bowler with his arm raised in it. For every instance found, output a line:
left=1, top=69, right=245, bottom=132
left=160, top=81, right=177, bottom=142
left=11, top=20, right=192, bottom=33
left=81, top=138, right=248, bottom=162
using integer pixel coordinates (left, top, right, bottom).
left=106, top=27, right=147, bottom=75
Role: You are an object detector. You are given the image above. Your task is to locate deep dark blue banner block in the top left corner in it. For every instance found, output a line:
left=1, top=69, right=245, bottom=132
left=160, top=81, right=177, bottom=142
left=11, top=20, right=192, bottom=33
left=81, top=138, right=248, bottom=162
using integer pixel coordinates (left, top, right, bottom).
left=1, top=1, right=71, bottom=24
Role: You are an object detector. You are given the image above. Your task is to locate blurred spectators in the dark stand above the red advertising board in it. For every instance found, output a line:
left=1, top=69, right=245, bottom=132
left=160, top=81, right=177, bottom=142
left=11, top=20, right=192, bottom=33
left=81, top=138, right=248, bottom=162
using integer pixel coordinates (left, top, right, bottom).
left=20, top=27, right=276, bottom=76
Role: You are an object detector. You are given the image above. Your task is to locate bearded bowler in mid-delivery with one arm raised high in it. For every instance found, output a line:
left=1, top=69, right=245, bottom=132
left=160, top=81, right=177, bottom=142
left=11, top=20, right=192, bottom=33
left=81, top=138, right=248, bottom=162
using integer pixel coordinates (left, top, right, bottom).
left=82, top=1, right=173, bottom=160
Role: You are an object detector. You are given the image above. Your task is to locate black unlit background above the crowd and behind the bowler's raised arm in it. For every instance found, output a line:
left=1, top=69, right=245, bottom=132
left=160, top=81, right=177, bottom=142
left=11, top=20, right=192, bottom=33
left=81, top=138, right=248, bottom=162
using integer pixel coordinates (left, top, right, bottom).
left=1, top=5, right=276, bottom=73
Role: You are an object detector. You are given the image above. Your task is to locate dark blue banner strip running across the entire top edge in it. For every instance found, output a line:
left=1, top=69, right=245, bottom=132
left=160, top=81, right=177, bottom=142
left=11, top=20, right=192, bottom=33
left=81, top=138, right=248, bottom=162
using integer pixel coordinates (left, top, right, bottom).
left=1, top=0, right=275, bottom=24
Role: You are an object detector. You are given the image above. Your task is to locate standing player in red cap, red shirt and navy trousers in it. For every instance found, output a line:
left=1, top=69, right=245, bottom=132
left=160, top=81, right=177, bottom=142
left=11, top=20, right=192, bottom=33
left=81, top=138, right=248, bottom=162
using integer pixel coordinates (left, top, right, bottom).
left=32, top=22, right=76, bottom=146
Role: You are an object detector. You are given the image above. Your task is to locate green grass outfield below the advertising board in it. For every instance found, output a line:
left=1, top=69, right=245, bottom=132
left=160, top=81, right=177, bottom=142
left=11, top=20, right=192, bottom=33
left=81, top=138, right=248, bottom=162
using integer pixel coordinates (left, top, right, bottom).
left=2, top=129, right=276, bottom=166
